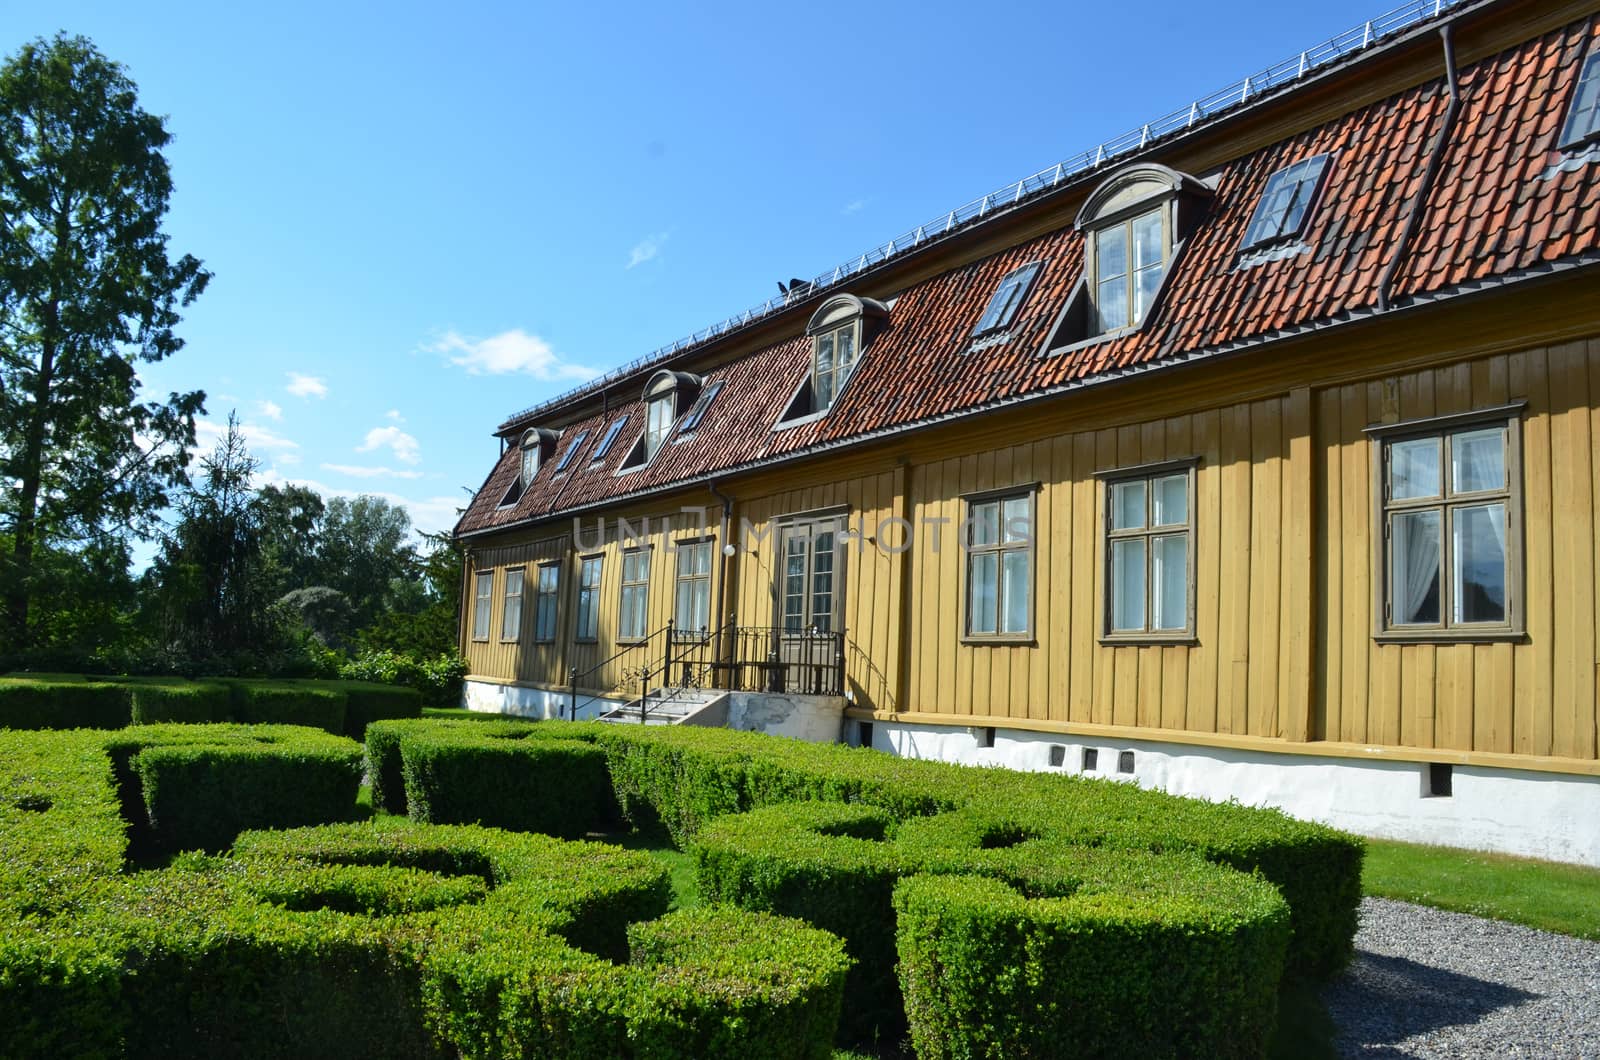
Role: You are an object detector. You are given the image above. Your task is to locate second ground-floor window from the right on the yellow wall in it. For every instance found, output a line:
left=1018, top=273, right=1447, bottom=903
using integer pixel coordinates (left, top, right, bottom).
left=1102, top=461, right=1195, bottom=640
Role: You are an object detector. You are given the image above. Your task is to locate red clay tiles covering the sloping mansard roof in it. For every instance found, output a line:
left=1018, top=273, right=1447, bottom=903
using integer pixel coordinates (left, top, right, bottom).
left=456, top=18, right=1600, bottom=533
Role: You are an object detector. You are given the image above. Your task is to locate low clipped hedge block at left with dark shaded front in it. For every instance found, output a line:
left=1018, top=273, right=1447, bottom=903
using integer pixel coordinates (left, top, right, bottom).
left=104, top=725, right=362, bottom=850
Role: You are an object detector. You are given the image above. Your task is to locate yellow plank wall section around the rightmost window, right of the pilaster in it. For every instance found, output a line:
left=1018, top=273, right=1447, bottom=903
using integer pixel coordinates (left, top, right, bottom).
left=1314, top=349, right=1600, bottom=759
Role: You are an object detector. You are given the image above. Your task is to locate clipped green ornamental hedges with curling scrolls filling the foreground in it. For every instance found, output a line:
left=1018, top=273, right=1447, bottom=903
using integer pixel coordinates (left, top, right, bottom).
left=0, top=719, right=1362, bottom=1060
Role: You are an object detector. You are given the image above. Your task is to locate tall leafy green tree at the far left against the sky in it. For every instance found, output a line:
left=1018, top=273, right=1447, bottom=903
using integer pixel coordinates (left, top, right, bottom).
left=0, top=35, right=210, bottom=647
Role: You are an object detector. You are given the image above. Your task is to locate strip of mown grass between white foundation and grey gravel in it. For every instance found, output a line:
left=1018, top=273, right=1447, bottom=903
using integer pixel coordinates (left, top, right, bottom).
left=1362, top=839, right=1600, bottom=938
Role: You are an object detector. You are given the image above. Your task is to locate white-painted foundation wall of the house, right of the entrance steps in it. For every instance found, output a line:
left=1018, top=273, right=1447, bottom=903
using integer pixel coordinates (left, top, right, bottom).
left=846, top=722, right=1600, bottom=866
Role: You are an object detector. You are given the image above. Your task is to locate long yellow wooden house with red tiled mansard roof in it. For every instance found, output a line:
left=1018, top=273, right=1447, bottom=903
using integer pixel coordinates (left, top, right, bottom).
left=456, top=0, right=1600, bottom=865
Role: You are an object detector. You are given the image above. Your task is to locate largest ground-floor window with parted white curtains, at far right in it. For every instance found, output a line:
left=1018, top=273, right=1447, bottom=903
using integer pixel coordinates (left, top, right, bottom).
left=1370, top=407, right=1522, bottom=640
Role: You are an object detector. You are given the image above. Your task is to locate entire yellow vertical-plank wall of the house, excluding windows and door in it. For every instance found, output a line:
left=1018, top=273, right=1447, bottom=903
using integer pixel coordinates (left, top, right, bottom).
left=462, top=339, right=1600, bottom=761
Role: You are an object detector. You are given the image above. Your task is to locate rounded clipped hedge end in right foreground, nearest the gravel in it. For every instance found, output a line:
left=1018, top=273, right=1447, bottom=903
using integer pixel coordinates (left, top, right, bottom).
left=894, top=864, right=1290, bottom=1060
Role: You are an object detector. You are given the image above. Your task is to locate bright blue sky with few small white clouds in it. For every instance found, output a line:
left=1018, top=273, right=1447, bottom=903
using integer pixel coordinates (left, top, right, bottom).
left=0, top=0, right=1392, bottom=544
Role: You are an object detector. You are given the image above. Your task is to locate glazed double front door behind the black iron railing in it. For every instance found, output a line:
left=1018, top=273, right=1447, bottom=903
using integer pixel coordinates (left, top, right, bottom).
left=778, top=514, right=845, bottom=695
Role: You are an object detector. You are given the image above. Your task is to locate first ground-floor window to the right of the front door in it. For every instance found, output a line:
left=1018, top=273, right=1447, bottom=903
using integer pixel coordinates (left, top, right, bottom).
left=963, top=487, right=1035, bottom=640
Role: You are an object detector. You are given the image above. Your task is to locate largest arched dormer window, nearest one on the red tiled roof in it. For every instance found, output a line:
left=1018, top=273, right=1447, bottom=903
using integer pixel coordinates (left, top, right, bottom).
left=1040, top=163, right=1211, bottom=354
